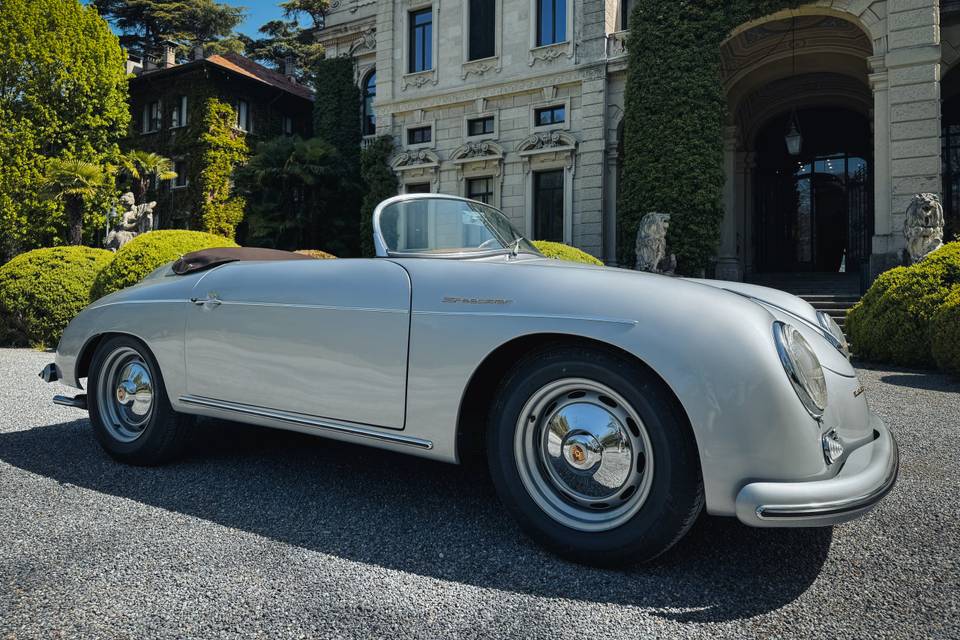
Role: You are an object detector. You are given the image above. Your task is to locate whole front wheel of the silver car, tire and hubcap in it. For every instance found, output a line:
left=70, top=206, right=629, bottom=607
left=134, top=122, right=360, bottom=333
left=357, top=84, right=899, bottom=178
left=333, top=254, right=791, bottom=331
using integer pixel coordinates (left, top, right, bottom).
left=487, top=345, right=703, bottom=565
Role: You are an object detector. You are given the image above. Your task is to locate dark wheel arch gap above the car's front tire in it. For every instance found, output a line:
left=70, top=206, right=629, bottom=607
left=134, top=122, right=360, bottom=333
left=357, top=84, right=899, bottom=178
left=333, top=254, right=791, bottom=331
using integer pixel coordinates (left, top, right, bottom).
left=456, top=333, right=699, bottom=466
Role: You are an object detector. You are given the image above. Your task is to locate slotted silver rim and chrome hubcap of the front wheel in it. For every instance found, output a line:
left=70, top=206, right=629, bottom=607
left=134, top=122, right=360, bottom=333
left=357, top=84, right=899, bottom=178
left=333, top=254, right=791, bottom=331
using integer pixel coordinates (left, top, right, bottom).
left=514, top=378, right=653, bottom=531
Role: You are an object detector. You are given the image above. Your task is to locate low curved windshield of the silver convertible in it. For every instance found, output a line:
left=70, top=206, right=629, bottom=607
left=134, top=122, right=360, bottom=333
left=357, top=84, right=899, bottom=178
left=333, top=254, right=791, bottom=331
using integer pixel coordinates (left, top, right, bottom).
left=377, top=196, right=539, bottom=256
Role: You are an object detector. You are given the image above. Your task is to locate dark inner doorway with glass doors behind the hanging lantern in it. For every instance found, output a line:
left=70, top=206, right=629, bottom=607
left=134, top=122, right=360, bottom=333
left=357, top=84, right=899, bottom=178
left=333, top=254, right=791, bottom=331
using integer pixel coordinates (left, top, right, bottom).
left=753, top=108, right=873, bottom=273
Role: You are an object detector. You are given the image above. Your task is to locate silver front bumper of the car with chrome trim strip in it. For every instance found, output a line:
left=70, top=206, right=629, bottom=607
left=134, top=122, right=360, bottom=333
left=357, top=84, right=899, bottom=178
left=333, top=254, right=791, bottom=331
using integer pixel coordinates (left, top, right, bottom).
left=737, top=413, right=900, bottom=527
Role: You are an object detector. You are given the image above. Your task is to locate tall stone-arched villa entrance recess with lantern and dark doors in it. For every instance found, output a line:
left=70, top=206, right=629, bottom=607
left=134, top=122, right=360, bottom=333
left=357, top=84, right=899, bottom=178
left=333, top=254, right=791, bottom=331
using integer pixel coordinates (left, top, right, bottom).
left=717, top=7, right=875, bottom=279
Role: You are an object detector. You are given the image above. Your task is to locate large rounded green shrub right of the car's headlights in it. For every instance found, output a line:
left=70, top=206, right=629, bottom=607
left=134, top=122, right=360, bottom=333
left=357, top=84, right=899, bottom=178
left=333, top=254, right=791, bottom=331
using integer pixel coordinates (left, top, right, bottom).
left=847, top=242, right=960, bottom=366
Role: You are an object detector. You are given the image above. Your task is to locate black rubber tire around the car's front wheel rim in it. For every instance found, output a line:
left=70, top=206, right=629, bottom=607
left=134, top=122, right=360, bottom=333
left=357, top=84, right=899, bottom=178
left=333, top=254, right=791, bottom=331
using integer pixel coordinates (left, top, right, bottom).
left=487, top=345, right=704, bottom=566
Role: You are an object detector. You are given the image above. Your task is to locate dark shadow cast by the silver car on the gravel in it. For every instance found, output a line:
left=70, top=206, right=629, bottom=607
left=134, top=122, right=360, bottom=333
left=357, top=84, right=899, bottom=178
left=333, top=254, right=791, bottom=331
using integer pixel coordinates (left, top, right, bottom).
left=0, top=419, right=832, bottom=622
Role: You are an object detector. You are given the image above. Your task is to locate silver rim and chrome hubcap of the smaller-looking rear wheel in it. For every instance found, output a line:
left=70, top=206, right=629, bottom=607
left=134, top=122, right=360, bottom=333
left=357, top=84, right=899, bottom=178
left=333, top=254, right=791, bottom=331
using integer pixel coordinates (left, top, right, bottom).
left=97, top=347, right=154, bottom=442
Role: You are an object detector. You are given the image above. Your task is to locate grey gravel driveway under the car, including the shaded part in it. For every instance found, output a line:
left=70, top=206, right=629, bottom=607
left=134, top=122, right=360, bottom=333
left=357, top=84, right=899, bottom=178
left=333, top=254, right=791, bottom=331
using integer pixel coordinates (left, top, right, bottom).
left=0, top=350, right=960, bottom=640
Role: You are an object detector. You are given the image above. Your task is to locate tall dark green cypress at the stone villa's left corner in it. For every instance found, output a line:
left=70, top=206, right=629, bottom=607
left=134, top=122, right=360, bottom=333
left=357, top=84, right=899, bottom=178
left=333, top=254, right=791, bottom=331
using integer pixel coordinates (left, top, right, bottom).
left=313, top=58, right=362, bottom=255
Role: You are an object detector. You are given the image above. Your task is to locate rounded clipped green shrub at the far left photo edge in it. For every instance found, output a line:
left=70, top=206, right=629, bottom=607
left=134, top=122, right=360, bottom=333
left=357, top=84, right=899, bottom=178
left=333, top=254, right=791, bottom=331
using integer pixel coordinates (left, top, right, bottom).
left=0, top=247, right=113, bottom=347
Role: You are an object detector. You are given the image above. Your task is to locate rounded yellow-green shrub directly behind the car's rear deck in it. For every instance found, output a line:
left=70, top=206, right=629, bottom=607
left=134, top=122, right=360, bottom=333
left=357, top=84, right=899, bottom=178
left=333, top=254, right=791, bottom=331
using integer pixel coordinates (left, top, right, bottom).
left=90, top=230, right=238, bottom=300
